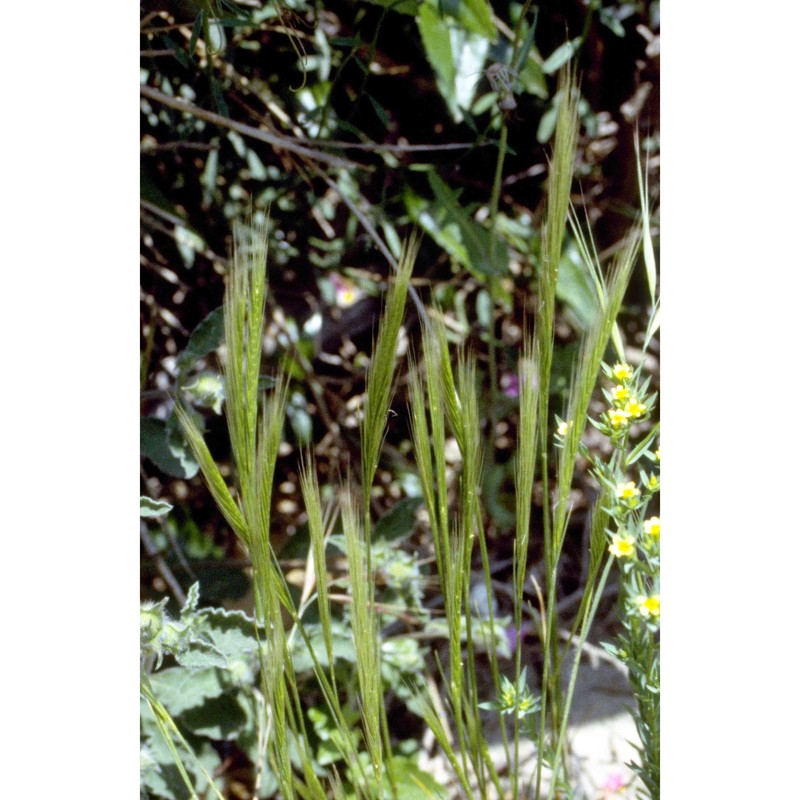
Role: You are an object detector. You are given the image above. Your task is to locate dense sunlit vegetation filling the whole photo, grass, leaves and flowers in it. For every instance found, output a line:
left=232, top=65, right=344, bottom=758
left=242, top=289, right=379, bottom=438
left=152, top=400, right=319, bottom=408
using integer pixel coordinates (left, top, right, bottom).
left=141, top=0, right=658, bottom=797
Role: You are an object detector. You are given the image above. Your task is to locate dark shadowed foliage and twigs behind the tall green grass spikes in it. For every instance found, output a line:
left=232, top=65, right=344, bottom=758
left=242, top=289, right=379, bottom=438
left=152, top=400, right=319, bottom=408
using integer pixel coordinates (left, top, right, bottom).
left=141, top=0, right=659, bottom=652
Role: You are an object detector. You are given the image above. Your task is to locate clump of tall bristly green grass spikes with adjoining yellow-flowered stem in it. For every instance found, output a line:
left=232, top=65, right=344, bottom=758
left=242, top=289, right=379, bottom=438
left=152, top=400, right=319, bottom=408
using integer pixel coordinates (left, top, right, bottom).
left=142, top=71, right=660, bottom=800
